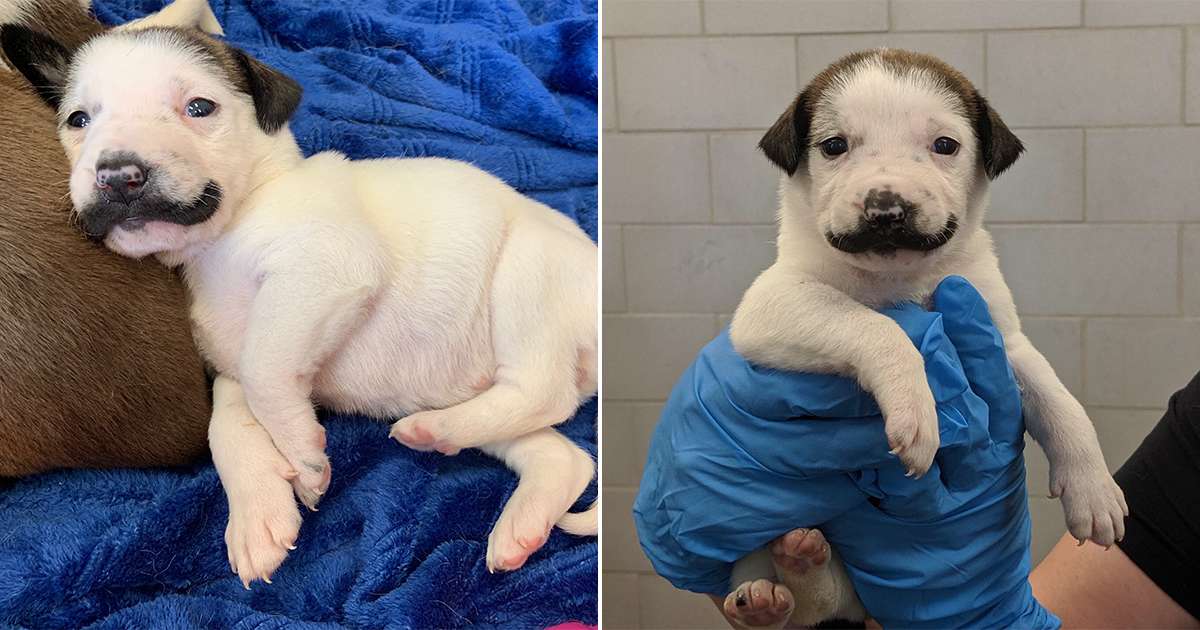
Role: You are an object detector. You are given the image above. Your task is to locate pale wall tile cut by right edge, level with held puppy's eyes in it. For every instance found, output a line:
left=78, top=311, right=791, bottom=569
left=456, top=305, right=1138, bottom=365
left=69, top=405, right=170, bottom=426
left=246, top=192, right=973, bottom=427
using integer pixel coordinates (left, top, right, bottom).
left=1087, top=127, right=1200, bottom=221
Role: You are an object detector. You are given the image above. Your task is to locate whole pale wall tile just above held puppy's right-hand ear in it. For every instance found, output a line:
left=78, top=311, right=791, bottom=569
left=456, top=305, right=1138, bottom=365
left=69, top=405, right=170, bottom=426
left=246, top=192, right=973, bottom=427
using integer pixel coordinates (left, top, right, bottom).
left=988, top=29, right=1183, bottom=127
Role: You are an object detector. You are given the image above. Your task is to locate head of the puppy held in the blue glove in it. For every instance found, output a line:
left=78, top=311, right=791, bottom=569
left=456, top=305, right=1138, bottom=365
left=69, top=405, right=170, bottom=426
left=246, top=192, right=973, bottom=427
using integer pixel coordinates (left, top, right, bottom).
left=758, top=49, right=1024, bottom=271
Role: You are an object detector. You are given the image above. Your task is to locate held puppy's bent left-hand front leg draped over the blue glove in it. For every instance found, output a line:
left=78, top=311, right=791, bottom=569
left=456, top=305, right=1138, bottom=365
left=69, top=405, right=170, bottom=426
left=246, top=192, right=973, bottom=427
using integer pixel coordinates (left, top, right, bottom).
left=730, top=263, right=938, bottom=475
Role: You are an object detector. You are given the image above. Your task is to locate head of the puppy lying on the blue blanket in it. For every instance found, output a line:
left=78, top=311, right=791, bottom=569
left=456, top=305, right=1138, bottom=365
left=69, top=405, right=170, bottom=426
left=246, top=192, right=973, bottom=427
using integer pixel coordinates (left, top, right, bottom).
left=0, top=26, right=300, bottom=257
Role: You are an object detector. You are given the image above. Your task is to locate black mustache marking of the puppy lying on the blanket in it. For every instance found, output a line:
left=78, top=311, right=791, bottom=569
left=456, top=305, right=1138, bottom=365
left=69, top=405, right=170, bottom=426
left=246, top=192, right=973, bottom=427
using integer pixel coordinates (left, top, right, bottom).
left=78, top=181, right=222, bottom=242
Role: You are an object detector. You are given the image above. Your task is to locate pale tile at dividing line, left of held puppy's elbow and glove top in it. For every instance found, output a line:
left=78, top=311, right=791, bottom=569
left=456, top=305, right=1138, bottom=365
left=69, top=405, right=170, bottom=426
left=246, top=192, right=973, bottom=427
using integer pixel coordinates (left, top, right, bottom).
left=604, top=314, right=716, bottom=401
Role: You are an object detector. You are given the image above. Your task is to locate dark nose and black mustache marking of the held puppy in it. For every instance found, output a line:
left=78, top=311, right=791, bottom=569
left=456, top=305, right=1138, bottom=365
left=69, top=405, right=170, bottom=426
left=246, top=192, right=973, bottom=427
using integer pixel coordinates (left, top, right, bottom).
left=826, top=188, right=959, bottom=256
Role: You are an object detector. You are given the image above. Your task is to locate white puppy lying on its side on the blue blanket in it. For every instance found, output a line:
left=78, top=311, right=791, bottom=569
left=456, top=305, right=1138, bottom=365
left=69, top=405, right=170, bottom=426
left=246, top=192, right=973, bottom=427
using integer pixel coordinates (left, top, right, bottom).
left=2, top=28, right=596, bottom=583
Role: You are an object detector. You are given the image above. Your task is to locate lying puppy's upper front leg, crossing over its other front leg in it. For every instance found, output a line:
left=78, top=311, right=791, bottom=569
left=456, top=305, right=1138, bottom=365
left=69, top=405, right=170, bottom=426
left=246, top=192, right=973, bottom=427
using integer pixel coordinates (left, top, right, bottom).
left=239, top=270, right=378, bottom=509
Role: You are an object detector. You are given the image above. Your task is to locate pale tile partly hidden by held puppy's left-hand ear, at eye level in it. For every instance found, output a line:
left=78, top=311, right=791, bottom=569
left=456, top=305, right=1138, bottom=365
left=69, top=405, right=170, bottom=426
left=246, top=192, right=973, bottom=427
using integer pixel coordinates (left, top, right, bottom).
left=708, top=131, right=782, bottom=223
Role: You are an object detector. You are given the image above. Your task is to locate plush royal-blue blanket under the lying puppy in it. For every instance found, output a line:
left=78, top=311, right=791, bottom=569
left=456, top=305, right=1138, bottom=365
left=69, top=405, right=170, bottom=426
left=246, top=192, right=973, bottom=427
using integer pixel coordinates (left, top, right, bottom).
left=0, top=0, right=598, bottom=628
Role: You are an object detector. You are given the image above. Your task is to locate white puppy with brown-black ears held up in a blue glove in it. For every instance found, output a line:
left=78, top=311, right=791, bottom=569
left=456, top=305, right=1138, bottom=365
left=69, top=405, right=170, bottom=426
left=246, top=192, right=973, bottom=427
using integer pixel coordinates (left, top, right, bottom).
left=725, top=49, right=1128, bottom=626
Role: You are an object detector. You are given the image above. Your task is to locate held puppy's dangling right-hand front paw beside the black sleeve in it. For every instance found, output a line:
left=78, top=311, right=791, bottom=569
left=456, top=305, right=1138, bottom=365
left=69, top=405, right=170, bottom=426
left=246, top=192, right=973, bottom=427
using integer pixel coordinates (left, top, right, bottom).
left=1050, top=456, right=1129, bottom=548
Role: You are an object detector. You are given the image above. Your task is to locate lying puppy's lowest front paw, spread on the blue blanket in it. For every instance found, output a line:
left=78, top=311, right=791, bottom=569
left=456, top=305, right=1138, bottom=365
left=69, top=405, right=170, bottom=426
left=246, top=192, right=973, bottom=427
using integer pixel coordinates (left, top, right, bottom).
left=226, top=479, right=300, bottom=590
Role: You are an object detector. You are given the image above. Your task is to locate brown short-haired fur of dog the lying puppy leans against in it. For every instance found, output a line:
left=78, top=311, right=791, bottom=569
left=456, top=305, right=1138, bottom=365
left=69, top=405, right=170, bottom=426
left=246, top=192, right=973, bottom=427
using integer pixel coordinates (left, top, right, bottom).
left=0, top=0, right=210, bottom=476
